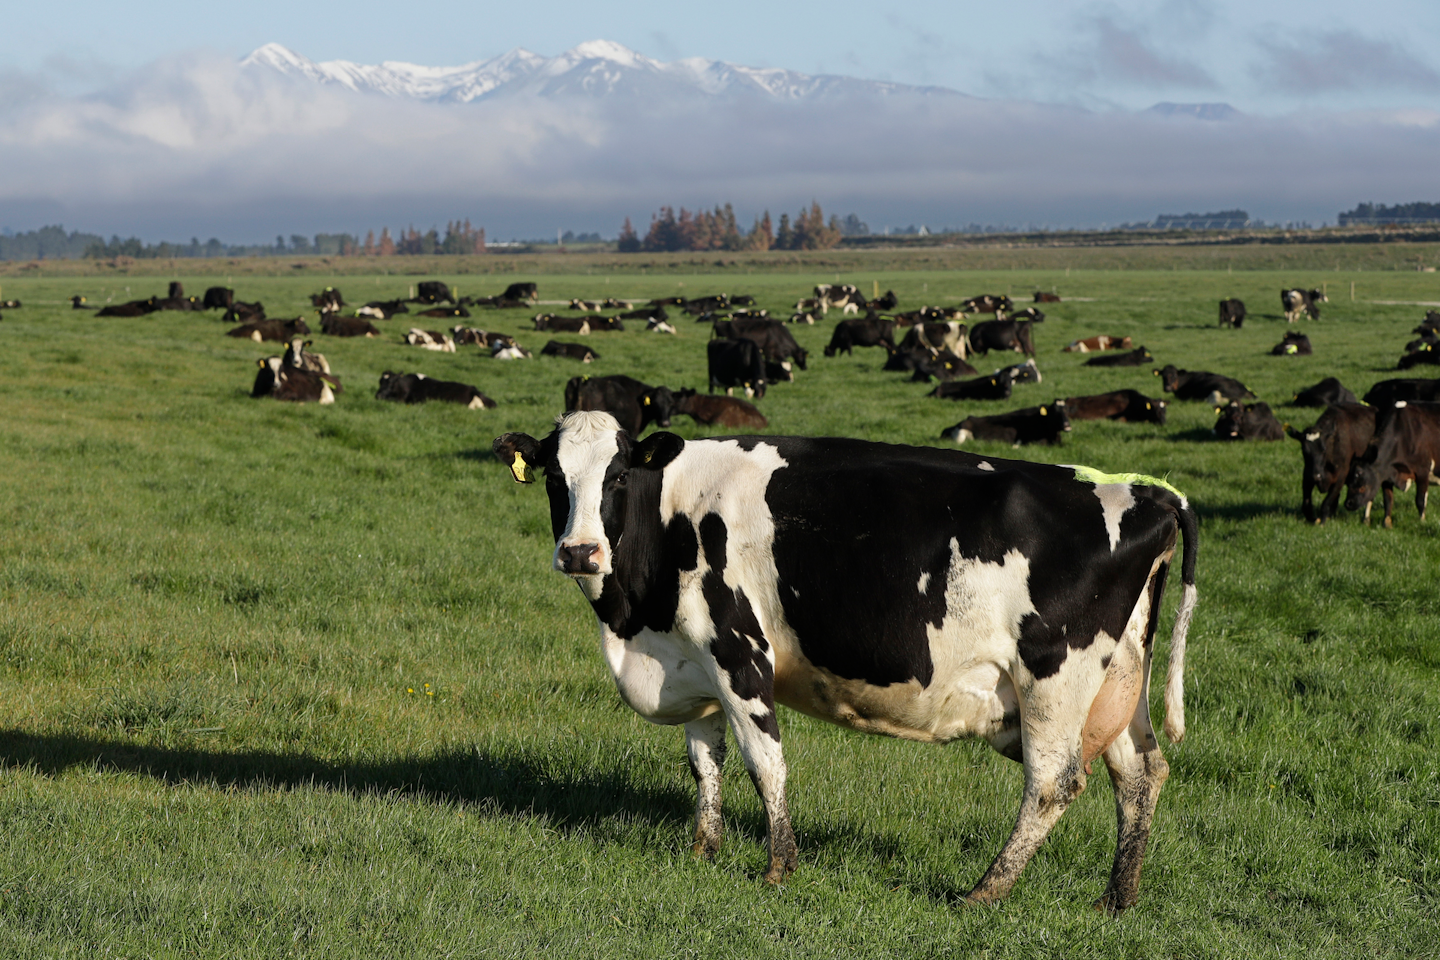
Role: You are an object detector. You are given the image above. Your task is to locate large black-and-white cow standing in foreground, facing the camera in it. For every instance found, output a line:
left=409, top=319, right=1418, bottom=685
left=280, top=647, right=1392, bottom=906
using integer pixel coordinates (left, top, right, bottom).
left=494, top=412, right=1197, bottom=913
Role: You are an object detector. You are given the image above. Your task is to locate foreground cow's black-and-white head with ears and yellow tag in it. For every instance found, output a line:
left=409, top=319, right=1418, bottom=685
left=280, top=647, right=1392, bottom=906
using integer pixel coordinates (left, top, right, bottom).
left=494, top=410, right=685, bottom=600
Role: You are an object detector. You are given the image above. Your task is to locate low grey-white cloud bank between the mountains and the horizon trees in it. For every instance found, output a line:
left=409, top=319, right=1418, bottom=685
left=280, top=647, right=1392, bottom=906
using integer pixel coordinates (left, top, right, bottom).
left=0, top=53, right=1440, bottom=242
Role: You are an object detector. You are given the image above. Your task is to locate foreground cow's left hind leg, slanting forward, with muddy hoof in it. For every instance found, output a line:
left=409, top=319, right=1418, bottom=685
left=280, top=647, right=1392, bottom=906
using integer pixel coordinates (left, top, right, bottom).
left=965, top=711, right=1099, bottom=904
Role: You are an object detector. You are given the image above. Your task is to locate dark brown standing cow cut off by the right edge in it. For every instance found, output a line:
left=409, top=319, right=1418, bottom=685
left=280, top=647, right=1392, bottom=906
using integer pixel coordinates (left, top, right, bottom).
left=1345, top=400, right=1440, bottom=530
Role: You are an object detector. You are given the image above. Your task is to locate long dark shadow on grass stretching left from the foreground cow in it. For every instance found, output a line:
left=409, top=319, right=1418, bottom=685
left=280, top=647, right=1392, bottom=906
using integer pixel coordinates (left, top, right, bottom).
left=0, top=730, right=691, bottom=832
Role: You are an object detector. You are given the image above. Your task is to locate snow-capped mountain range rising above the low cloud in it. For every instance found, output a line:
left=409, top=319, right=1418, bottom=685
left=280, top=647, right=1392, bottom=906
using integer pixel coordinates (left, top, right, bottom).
left=240, top=40, right=962, bottom=104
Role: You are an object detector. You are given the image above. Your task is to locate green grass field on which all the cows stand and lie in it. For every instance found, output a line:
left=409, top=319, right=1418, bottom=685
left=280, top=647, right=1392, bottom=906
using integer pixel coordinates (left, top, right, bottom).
left=0, top=259, right=1440, bottom=959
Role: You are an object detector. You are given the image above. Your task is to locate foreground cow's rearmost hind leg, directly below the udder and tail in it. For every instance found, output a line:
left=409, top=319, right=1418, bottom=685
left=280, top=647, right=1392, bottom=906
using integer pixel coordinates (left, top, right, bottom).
left=1094, top=716, right=1169, bottom=914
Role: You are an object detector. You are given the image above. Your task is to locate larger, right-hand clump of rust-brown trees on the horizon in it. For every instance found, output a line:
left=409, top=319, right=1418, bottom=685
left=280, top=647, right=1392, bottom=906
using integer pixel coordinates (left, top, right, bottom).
left=618, top=203, right=846, bottom=253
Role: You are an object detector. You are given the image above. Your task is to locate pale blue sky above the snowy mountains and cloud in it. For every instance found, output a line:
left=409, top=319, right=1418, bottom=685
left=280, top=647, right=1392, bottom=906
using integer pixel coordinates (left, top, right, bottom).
left=11, top=0, right=1440, bottom=114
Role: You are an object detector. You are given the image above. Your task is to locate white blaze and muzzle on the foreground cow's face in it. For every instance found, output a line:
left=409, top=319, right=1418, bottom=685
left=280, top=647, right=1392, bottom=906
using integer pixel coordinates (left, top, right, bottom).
left=546, top=410, right=628, bottom=599
